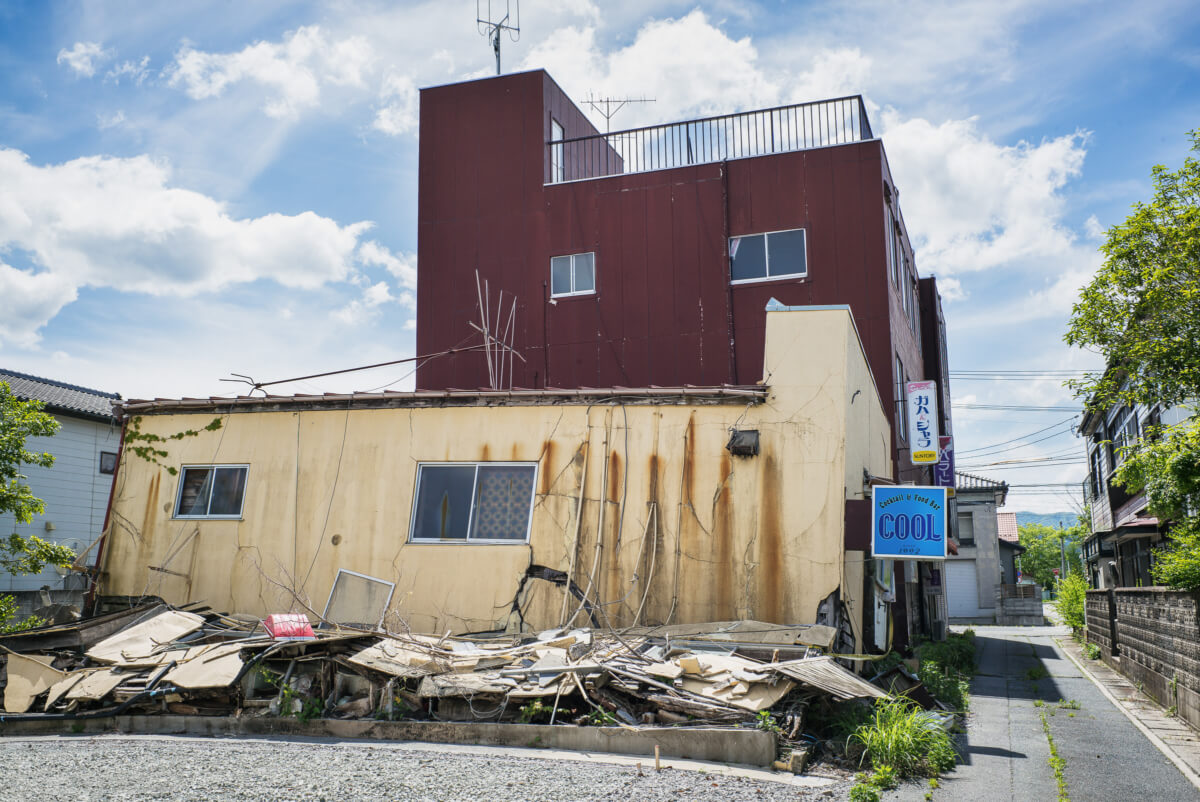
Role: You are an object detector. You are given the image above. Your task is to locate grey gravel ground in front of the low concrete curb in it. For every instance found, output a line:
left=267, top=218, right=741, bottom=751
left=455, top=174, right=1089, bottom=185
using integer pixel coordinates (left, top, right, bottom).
left=0, top=736, right=850, bottom=802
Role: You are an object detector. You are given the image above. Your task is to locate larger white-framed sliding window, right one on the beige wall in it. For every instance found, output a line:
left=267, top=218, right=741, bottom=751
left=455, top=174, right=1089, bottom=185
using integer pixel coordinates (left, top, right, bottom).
left=408, top=462, right=538, bottom=543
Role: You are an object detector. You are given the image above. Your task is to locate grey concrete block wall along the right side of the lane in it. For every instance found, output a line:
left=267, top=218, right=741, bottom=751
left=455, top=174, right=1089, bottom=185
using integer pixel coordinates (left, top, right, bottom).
left=1087, top=587, right=1200, bottom=726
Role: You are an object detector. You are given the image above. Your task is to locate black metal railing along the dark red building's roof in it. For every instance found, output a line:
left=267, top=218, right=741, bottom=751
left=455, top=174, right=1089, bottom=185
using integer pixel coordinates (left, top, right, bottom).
left=546, top=95, right=874, bottom=184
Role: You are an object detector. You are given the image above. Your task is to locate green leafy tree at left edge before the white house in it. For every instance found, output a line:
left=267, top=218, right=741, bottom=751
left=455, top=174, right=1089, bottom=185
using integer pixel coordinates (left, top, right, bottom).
left=0, top=382, right=74, bottom=632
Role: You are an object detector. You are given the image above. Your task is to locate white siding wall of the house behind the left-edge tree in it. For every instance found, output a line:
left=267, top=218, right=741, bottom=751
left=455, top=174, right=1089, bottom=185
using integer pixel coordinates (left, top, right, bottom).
left=0, top=414, right=121, bottom=592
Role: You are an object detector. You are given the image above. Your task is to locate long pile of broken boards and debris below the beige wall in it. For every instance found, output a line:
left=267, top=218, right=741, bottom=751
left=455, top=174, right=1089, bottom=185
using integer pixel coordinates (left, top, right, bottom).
left=0, top=604, right=887, bottom=737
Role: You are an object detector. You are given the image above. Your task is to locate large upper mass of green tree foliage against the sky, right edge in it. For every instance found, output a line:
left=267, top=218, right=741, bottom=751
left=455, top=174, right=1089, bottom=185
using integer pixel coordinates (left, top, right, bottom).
left=1066, top=128, right=1200, bottom=409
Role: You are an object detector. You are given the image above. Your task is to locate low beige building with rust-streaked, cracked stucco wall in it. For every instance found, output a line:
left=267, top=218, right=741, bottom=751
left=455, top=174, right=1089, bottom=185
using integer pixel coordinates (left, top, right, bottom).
left=98, top=307, right=890, bottom=648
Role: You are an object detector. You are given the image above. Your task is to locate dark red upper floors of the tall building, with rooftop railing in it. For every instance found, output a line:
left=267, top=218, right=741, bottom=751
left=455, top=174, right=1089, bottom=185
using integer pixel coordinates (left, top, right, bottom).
left=416, top=70, right=936, bottom=475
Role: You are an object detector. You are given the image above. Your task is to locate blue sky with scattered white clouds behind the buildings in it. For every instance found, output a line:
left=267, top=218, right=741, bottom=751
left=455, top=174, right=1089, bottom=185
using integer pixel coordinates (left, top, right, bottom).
left=0, top=0, right=1200, bottom=510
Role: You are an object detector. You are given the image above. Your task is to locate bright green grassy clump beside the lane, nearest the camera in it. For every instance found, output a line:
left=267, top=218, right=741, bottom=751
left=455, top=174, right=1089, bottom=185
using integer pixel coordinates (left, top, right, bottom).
left=850, top=698, right=955, bottom=777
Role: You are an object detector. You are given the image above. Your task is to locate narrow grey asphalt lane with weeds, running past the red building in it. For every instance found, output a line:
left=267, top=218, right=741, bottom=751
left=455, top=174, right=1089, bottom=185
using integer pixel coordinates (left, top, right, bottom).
left=884, top=627, right=1200, bottom=802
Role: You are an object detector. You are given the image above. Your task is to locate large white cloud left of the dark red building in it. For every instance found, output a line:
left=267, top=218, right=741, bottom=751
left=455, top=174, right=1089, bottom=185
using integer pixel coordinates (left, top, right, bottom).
left=0, top=149, right=379, bottom=343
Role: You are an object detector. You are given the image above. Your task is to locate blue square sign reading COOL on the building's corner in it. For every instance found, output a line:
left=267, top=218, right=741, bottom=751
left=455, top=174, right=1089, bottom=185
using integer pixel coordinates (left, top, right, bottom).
left=871, top=485, right=947, bottom=559
